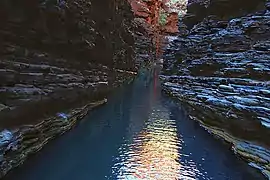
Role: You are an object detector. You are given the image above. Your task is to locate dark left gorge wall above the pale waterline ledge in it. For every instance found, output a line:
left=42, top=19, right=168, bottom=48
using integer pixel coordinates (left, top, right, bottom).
left=0, top=0, right=141, bottom=128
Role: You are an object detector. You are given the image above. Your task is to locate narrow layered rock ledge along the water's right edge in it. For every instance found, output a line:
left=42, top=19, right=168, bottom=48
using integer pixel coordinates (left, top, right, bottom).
left=163, top=86, right=270, bottom=179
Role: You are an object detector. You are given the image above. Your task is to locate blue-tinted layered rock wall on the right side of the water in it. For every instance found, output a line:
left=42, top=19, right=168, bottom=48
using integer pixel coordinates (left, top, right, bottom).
left=161, top=2, right=270, bottom=177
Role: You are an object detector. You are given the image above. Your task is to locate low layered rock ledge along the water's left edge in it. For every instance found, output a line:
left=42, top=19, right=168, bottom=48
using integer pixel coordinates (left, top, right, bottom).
left=0, top=99, right=107, bottom=178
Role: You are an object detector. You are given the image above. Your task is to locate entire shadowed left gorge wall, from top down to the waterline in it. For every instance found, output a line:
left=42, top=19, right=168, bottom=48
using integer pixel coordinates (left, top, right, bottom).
left=0, top=0, right=154, bottom=177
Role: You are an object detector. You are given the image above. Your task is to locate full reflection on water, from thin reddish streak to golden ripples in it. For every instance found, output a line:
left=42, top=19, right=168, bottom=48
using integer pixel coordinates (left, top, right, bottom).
left=112, top=67, right=199, bottom=180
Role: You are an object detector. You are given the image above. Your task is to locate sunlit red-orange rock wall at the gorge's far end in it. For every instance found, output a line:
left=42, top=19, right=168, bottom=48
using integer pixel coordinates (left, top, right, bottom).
left=128, top=0, right=185, bottom=59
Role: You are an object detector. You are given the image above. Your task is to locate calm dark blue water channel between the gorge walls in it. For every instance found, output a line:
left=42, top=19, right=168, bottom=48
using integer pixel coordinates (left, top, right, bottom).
left=5, top=67, right=264, bottom=180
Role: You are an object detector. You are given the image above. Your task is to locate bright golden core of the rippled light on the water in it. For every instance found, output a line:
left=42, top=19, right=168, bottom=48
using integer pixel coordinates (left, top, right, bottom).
left=129, top=120, right=180, bottom=180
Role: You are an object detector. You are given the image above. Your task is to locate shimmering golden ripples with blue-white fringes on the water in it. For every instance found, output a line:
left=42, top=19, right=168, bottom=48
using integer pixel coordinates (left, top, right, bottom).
left=112, top=106, right=196, bottom=180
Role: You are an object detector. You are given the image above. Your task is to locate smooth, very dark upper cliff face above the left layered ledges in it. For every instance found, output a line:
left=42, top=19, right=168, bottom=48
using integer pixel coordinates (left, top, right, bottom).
left=0, top=0, right=134, bottom=69
